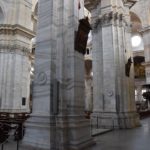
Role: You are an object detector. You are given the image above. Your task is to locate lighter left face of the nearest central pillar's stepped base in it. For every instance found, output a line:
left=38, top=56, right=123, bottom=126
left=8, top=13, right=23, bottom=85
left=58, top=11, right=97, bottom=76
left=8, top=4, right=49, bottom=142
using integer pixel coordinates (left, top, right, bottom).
left=21, top=115, right=56, bottom=150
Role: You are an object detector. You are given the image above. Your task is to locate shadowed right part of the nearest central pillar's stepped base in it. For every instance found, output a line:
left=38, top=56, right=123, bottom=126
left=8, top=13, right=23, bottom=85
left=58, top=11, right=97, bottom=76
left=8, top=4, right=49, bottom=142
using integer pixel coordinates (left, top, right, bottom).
left=57, top=115, right=95, bottom=150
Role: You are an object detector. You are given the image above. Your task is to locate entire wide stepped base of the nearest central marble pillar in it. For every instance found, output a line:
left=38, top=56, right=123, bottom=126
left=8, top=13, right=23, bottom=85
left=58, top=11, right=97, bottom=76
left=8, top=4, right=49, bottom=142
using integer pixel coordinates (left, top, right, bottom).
left=21, top=115, right=95, bottom=150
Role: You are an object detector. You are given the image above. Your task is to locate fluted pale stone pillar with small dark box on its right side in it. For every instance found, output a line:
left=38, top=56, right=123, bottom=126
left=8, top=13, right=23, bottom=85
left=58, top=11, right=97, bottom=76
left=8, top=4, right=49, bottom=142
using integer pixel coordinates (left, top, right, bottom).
left=92, top=0, right=139, bottom=129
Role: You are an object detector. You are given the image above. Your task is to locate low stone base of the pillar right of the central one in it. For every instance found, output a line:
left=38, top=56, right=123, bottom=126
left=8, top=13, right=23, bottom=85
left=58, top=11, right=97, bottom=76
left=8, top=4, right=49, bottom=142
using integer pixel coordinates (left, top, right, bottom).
left=92, top=112, right=140, bottom=129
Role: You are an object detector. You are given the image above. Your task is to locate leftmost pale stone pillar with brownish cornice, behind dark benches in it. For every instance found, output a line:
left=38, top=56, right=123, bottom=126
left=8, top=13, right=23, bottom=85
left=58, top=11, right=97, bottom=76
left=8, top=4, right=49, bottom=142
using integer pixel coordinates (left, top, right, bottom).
left=0, top=0, right=34, bottom=113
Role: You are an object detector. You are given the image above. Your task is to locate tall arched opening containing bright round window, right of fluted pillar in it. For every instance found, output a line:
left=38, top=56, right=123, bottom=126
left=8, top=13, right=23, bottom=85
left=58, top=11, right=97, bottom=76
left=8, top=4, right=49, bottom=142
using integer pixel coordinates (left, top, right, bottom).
left=130, top=12, right=145, bottom=113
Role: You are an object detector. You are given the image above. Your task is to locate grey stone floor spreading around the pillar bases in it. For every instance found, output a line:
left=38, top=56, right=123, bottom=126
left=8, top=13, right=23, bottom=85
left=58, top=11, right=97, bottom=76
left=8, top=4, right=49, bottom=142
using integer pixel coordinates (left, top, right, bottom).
left=0, top=118, right=150, bottom=150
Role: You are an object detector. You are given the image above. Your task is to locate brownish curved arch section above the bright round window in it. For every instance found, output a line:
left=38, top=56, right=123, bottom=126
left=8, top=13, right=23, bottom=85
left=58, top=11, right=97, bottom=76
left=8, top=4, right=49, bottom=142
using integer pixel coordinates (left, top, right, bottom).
left=130, top=11, right=142, bottom=33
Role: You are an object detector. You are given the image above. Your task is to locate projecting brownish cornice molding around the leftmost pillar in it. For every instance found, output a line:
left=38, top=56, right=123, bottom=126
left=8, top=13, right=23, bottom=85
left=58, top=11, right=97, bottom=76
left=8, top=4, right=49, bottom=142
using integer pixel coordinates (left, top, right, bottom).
left=0, top=24, right=35, bottom=39
